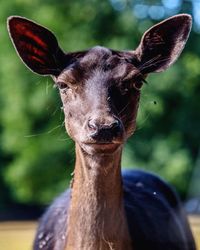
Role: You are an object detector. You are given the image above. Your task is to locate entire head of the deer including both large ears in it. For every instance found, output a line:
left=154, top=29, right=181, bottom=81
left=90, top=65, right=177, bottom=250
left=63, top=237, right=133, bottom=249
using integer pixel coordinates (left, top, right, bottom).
left=8, top=14, right=191, bottom=154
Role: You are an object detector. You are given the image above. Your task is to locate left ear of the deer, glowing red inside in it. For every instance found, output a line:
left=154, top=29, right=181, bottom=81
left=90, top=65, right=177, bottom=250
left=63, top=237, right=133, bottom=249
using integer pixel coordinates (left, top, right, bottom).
left=8, top=16, right=66, bottom=76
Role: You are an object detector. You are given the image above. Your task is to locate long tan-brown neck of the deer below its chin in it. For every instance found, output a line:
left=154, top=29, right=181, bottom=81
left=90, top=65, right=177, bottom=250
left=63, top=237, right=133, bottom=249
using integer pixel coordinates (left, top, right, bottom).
left=66, top=145, right=131, bottom=250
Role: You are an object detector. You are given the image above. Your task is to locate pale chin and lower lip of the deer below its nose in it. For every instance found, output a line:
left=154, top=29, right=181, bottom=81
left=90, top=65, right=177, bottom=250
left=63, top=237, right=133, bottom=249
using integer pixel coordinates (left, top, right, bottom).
left=80, top=142, right=123, bottom=155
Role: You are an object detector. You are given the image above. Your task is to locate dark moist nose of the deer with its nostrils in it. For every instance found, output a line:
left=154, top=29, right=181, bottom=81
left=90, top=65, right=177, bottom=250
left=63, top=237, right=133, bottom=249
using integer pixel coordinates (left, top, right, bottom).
left=88, top=118, right=122, bottom=142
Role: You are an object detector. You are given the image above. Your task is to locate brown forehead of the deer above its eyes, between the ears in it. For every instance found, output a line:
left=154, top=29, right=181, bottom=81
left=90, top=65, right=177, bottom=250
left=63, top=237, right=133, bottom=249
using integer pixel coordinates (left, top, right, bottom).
left=57, top=46, right=139, bottom=88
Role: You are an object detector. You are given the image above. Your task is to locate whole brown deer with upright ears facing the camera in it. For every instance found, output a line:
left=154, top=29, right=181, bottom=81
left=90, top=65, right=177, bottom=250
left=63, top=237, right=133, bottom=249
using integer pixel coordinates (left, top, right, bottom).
left=8, top=14, right=196, bottom=250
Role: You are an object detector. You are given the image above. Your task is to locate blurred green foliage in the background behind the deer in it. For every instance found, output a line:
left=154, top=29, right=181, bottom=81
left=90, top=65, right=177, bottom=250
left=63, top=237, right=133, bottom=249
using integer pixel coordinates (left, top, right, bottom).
left=0, top=0, right=200, bottom=206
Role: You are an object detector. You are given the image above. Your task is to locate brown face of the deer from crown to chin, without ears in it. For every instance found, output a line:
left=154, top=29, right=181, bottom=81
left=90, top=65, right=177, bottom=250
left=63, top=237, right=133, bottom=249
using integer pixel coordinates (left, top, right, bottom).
left=55, top=47, right=143, bottom=151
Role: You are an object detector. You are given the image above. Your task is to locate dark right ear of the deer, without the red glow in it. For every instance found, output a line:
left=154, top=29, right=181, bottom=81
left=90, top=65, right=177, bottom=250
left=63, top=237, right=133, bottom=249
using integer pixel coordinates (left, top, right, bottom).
left=135, top=14, right=192, bottom=73
